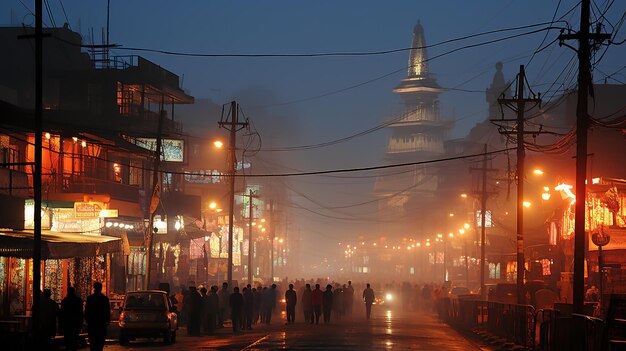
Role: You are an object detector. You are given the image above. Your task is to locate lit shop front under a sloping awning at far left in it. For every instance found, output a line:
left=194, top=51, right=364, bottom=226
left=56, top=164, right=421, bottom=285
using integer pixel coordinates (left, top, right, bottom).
left=0, top=230, right=121, bottom=316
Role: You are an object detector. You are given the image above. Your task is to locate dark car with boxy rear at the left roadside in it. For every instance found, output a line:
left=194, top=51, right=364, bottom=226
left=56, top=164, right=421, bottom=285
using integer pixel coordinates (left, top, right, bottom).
left=119, top=290, right=178, bottom=345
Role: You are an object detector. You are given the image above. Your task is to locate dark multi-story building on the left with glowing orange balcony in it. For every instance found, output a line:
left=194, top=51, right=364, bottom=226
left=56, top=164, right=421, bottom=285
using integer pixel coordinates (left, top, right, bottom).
left=0, top=27, right=199, bottom=312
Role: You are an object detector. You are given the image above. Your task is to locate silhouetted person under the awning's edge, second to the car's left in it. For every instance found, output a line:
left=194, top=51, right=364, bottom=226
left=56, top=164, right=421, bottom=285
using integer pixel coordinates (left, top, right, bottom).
left=59, top=286, right=83, bottom=351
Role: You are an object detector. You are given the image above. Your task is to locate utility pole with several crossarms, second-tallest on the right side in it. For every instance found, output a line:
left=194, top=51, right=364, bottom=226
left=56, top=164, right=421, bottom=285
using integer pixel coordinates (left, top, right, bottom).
left=492, top=65, right=541, bottom=304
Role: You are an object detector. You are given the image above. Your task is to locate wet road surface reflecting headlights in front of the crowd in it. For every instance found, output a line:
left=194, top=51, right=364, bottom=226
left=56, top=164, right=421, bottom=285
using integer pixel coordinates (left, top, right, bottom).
left=105, top=306, right=489, bottom=351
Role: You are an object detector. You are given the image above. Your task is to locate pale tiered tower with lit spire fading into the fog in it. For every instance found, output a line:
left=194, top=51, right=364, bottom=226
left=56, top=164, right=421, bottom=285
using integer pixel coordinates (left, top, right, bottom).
left=374, top=21, right=454, bottom=236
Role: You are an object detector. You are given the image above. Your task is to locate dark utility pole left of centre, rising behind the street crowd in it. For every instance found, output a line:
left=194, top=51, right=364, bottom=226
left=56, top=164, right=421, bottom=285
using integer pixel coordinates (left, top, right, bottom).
left=218, top=101, right=248, bottom=288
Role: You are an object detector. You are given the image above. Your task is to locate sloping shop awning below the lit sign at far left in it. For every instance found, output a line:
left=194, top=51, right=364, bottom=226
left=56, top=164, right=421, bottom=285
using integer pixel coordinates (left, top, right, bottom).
left=0, top=230, right=122, bottom=260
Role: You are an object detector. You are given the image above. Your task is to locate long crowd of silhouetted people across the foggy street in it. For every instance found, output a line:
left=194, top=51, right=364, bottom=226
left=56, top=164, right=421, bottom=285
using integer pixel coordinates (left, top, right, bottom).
left=170, top=279, right=454, bottom=336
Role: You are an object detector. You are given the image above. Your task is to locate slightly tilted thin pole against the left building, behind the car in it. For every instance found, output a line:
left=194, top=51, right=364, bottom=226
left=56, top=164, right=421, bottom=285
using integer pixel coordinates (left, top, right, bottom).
left=145, top=102, right=167, bottom=290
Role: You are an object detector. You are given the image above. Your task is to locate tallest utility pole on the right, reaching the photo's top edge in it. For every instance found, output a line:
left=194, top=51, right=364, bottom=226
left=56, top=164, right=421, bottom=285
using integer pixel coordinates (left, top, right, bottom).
left=559, top=0, right=611, bottom=313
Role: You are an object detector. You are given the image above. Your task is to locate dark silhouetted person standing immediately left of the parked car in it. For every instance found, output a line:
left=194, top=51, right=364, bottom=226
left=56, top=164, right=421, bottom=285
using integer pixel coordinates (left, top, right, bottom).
left=85, top=282, right=111, bottom=351
